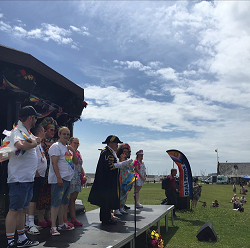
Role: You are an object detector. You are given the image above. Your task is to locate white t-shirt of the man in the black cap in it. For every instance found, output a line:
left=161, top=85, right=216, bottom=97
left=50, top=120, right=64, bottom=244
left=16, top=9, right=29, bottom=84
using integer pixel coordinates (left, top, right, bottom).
left=7, top=121, right=37, bottom=183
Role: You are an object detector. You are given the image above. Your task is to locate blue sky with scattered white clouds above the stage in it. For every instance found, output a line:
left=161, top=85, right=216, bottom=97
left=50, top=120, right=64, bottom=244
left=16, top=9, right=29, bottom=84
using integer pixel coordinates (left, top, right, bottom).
left=0, top=1, right=250, bottom=175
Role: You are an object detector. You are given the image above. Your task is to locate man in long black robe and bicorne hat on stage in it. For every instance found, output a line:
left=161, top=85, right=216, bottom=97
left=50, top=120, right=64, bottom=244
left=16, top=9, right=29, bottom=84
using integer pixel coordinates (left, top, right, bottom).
left=88, top=135, right=133, bottom=224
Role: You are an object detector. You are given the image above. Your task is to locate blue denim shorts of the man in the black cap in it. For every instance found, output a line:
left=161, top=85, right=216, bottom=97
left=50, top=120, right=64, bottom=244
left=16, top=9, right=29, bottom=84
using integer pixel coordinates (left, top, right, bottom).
left=8, top=182, right=34, bottom=211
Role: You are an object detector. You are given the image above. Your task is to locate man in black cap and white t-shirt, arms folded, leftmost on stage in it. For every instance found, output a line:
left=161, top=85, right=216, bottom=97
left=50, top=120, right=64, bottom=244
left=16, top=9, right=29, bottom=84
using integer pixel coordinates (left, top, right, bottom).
left=5, top=106, right=41, bottom=248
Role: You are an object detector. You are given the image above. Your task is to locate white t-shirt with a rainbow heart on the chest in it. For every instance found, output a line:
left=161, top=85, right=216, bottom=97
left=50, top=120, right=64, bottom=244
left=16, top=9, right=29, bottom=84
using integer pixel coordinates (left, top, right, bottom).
left=48, top=142, right=74, bottom=184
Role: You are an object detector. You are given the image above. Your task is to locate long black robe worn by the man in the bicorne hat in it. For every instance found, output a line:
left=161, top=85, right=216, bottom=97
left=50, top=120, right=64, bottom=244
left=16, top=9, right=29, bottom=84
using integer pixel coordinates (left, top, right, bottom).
left=88, top=146, right=120, bottom=209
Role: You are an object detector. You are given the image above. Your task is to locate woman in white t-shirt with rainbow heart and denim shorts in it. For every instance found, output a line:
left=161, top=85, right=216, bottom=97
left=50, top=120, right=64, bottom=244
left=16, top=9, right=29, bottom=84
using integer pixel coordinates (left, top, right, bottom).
left=48, top=127, right=78, bottom=235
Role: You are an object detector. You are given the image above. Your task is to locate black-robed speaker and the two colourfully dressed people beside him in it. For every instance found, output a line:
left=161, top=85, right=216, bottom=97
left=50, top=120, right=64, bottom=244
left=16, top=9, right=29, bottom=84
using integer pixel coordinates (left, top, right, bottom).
left=88, top=135, right=146, bottom=224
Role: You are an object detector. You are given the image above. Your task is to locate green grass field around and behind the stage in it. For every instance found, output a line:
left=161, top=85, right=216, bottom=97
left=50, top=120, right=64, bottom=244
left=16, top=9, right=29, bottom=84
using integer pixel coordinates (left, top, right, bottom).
left=78, top=183, right=250, bottom=248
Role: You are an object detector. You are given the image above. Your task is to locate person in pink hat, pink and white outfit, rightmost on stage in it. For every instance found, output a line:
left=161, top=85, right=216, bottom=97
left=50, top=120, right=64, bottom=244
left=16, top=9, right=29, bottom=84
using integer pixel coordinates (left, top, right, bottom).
left=134, top=150, right=146, bottom=208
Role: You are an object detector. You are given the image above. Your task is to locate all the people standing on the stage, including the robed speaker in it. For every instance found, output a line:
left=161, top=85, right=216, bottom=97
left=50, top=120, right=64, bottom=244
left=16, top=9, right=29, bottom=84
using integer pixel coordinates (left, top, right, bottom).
left=0, top=106, right=146, bottom=248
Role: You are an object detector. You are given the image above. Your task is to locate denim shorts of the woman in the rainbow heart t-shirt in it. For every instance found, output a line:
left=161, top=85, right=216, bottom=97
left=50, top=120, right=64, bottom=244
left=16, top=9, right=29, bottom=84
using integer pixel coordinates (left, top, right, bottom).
left=51, top=180, right=70, bottom=208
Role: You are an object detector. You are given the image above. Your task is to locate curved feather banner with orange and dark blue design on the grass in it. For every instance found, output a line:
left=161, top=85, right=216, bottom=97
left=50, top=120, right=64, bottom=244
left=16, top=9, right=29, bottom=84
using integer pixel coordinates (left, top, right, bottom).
left=167, top=150, right=193, bottom=197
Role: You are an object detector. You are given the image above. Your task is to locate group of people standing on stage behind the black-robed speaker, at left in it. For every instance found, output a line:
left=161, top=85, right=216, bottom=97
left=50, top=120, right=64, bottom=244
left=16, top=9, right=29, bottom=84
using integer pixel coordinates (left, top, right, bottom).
left=0, top=106, right=87, bottom=247
